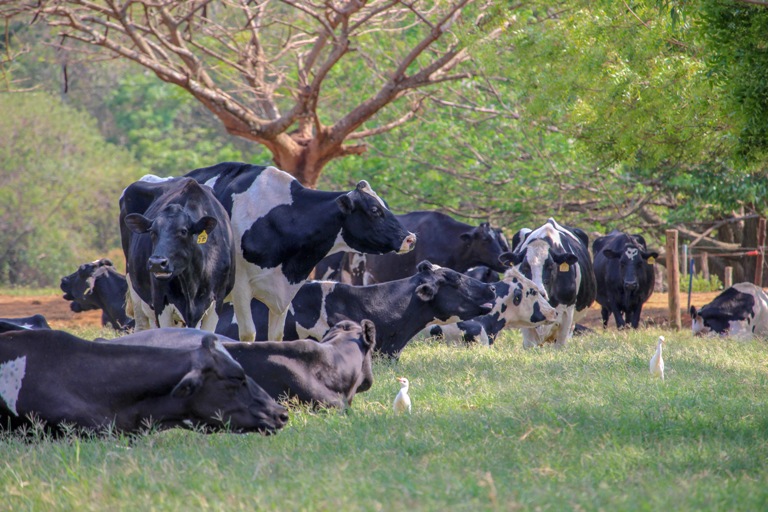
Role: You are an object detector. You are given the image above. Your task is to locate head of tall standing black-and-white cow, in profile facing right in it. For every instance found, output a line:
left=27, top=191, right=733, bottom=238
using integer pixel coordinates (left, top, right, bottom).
left=336, top=180, right=416, bottom=254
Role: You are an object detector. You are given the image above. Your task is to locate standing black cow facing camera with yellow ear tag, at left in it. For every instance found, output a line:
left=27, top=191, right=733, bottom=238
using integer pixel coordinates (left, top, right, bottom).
left=120, top=177, right=235, bottom=331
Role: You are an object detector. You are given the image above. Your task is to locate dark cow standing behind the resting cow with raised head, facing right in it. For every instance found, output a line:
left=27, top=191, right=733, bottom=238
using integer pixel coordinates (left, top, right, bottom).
left=342, top=211, right=509, bottom=285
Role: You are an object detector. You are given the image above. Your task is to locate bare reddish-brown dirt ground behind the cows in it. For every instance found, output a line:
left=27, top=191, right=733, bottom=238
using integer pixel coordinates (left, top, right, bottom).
left=0, top=292, right=718, bottom=329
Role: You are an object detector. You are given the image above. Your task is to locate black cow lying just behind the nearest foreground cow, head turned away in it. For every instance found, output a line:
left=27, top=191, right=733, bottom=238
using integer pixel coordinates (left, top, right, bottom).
left=98, top=320, right=376, bottom=407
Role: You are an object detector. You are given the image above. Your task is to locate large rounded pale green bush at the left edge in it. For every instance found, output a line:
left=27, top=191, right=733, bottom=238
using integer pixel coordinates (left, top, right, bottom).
left=0, top=93, right=139, bottom=286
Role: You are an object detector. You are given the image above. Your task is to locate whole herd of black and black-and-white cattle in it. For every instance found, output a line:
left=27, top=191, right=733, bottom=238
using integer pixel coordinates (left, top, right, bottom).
left=0, top=163, right=768, bottom=433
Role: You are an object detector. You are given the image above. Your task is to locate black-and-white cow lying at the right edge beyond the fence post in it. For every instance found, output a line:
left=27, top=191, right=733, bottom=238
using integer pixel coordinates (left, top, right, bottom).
left=690, top=283, right=768, bottom=339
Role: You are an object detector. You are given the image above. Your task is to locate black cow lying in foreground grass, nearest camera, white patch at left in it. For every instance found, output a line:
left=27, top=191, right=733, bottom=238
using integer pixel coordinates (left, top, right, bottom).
left=0, top=330, right=288, bottom=432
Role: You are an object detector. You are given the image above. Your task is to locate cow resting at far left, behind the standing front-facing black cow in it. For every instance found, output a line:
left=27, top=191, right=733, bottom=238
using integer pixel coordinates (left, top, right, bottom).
left=60, top=258, right=134, bottom=331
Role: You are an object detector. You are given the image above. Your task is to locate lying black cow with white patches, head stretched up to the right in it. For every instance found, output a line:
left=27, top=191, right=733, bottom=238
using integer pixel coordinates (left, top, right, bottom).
left=243, top=261, right=495, bottom=358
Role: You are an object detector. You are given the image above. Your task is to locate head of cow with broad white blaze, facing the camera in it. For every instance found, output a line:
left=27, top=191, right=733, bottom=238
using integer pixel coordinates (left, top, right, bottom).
left=499, top=239, right=579, bottom=307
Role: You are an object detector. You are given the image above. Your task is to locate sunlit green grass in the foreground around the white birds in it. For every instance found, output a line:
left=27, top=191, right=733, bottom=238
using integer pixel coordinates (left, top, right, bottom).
left=0, top=330, right=768, bottom=511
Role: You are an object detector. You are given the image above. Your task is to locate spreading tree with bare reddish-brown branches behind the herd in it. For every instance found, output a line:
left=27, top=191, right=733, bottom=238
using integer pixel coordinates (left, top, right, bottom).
left=5, top=0, right=500, bottom=186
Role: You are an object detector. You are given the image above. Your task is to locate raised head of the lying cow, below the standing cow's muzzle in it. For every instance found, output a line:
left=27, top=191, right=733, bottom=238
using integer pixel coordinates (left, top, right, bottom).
left=413, top=260, right=496, bottom=324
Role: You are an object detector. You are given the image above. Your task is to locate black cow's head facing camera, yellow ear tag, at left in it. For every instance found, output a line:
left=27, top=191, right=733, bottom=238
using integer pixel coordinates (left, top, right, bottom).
left=125, top=204, right=218, bottom=280
